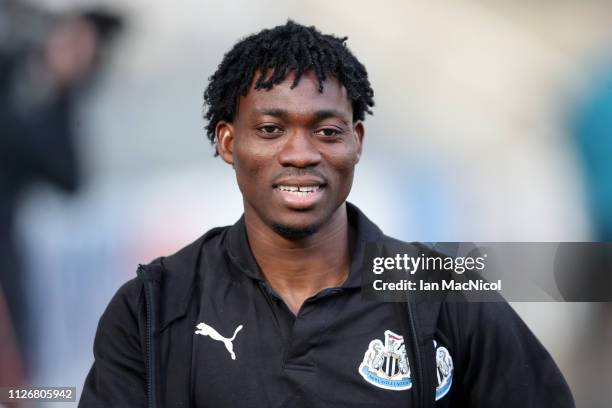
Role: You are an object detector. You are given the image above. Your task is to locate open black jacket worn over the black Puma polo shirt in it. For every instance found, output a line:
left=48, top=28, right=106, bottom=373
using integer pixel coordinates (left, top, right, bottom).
left=79, top=204, right=574, bottom=408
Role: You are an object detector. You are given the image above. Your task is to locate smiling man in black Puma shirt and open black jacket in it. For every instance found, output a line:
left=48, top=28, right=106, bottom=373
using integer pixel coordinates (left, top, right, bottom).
left=80, top=21, right=573, bottom=407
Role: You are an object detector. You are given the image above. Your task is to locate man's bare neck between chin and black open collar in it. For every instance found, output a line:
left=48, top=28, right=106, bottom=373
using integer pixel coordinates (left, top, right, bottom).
left=245, top=204, right=355, bottom=315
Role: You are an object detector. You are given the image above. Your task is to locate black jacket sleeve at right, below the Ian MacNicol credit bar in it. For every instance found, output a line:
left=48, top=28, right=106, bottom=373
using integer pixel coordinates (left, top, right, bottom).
left=455, top=301, right=575, bottom=408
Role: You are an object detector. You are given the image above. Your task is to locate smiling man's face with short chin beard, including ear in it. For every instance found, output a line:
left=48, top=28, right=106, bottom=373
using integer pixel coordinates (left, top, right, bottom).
left=216, top=72, right=363, bottom=238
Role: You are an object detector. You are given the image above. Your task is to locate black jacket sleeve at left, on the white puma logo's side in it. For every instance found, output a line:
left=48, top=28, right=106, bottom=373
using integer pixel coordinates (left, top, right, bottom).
left=79, top=279, right=147, bottom=408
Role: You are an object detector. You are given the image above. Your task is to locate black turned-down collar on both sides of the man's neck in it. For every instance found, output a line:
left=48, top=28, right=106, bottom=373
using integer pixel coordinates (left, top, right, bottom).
left=226, top=201, right=384, bottom=288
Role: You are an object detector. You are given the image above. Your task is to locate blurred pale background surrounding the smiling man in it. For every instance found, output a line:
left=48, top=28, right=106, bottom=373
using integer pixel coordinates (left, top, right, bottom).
left=0, top=0, right=612, bottom=408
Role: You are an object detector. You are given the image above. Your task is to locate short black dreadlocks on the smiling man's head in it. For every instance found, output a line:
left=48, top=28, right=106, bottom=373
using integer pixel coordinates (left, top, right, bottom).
left=204, top=20, right=374, bottom=155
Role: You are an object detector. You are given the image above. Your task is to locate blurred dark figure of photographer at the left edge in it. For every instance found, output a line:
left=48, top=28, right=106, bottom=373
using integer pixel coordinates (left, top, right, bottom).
left=0, top=0, right=122, bottom=385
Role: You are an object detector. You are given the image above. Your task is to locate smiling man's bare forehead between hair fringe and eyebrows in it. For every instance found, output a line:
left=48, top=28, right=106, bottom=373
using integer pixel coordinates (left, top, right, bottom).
left=237, top=71, right=353, bottom=120
